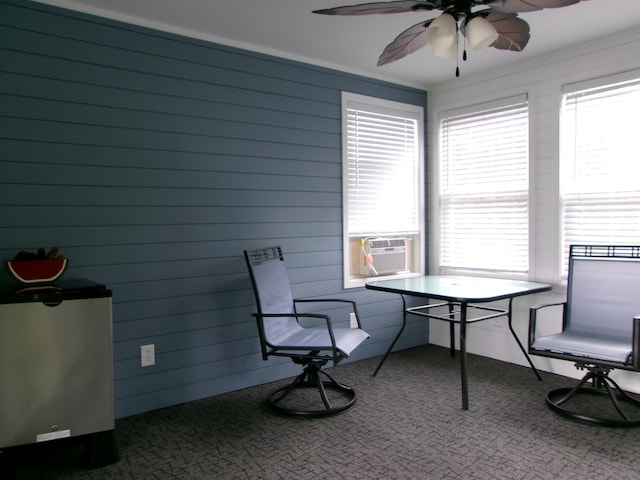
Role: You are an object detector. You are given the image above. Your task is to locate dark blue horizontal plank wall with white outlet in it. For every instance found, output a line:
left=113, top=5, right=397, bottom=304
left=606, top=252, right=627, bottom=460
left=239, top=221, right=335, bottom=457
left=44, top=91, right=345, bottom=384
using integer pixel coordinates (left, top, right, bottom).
left=0, top=0, right=427, bottom=417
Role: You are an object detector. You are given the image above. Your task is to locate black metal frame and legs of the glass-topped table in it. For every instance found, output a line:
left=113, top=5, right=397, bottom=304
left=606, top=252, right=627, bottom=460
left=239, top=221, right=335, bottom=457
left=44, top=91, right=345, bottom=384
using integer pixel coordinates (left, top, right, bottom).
left=365, top=275, right=551, bottom=410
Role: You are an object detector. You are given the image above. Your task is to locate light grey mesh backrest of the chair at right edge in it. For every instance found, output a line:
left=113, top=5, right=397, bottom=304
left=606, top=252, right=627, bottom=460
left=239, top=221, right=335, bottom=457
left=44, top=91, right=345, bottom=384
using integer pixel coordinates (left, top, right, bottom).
left=565, top=245, right=640, bottom=340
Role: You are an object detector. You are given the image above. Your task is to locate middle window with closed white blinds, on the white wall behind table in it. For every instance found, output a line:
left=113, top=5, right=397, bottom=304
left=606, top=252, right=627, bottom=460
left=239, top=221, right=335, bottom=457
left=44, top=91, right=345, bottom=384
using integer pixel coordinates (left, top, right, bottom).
left=439, top=95, right=529, bottom=276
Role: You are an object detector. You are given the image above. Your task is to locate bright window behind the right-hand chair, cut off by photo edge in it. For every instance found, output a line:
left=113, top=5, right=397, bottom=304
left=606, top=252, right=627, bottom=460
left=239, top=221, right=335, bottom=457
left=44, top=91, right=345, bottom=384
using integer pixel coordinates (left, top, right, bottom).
left=560, top=70, right=640, bottom=278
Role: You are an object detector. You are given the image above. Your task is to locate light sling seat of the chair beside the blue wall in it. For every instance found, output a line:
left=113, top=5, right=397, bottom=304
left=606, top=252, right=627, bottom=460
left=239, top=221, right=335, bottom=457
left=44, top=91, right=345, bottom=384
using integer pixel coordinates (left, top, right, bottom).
left=274, top=328, right=369, bottom=356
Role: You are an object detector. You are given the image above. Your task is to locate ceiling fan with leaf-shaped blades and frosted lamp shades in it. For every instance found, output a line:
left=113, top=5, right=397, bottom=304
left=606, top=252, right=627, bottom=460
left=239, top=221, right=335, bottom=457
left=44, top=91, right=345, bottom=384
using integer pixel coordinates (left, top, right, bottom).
left=313, top=0, right=581, bottom=76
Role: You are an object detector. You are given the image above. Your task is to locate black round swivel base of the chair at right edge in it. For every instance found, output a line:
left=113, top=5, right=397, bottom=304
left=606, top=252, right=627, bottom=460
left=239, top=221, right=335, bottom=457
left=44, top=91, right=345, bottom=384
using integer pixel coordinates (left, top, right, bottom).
left=547, top=367, right=640, bottom=427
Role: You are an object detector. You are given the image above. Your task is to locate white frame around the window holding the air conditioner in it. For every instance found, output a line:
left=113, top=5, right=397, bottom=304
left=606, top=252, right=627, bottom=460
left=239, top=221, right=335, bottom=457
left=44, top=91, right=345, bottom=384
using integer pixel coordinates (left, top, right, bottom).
left=341, top=91, right=426, bottom=289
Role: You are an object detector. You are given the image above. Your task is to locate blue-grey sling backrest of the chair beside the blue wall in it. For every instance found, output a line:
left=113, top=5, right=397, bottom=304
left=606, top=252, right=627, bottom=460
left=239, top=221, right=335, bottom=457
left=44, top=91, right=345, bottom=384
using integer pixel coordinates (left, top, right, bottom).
left=244, top=247, right=301, bottom=345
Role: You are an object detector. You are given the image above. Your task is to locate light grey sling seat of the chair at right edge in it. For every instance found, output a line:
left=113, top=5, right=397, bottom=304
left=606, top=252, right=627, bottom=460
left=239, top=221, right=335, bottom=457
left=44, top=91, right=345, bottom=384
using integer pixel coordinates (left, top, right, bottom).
left=531, top=331, right=632, bottom=364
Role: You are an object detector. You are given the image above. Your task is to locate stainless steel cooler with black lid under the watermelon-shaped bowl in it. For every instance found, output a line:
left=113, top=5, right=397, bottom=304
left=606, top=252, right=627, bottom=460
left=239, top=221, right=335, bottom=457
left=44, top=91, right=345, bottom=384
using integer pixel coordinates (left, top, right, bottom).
left=0, top=280, right=117, bottom=466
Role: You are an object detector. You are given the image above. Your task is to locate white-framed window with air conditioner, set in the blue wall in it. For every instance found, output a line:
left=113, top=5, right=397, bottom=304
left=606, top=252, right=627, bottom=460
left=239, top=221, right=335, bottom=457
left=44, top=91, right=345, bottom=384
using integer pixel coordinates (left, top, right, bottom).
left=342, top=92, right=425, bottom=287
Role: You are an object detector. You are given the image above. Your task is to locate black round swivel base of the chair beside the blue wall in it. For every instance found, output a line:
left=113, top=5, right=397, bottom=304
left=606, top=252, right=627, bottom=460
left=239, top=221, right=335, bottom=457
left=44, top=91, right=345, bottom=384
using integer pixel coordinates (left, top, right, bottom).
left=269, top=363, right=356, bottom=417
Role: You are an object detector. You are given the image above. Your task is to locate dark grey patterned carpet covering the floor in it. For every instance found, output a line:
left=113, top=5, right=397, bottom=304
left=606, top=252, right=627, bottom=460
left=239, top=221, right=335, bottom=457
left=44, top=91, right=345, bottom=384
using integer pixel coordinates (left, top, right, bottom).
left=5, top=346, right=640, bottom=480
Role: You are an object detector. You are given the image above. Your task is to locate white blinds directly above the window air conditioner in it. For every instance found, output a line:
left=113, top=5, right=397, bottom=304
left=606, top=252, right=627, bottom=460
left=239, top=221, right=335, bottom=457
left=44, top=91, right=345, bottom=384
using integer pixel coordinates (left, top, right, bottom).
left=344, top=96, right=422, bottom=236
